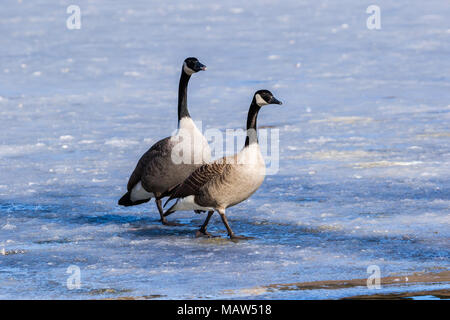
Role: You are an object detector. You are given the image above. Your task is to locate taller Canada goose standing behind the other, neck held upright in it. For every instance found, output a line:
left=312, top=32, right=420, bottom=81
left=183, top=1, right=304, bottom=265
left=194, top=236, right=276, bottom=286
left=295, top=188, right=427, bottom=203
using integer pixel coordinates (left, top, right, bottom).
left=119, top=58, right=211, bottom=225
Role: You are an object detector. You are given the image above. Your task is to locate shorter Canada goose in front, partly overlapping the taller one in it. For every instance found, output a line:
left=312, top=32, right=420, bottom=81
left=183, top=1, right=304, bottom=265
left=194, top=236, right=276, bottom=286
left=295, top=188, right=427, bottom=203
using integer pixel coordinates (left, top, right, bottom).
left=164, top=90, right=281, bottom=239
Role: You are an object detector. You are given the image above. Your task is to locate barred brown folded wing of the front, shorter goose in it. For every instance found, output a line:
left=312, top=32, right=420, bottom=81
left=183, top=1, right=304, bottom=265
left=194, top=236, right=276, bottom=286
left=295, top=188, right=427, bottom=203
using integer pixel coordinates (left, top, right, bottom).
left=164, top=161, right=229, bottom=205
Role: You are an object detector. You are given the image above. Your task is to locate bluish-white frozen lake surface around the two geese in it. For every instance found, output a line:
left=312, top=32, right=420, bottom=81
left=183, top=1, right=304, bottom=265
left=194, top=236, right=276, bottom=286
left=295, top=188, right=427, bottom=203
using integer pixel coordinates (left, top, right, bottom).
left=0, top=0, right=450, bottom=299
